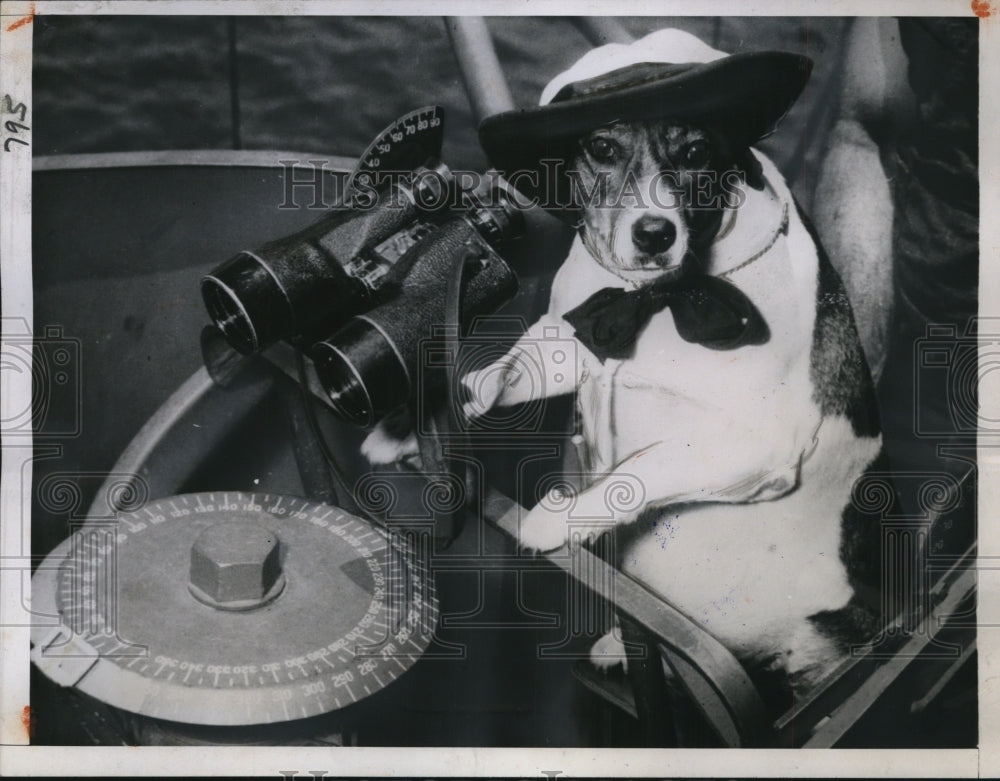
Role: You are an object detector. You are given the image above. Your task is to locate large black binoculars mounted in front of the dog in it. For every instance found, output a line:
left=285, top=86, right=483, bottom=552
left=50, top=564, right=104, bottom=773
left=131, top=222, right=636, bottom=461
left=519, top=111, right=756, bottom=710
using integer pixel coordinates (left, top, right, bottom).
left=201, top=161, right=523, bottom=426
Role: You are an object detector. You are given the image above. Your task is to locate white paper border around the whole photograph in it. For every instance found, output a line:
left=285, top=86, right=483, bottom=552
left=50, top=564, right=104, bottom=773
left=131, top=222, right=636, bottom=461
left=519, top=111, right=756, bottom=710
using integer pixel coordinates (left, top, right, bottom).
left=0, top=0, right=1000, bottom=778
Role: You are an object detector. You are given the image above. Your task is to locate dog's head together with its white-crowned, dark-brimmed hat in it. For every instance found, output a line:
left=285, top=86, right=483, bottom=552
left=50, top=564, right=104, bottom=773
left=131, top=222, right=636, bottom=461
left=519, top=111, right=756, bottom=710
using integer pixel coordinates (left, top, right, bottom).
left=479, top=28, right=812, bottom=284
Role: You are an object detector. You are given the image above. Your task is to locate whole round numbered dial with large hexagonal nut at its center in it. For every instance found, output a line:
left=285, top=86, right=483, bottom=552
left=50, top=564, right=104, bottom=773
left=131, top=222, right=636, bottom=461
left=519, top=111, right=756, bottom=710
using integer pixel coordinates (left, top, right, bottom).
left=32, top=491, right=437, bottom=740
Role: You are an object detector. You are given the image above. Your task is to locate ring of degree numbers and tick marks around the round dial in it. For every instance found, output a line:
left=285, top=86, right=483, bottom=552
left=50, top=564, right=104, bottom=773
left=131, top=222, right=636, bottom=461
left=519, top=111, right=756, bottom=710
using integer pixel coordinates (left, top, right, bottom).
left=43, top=492, right=437, bottom=721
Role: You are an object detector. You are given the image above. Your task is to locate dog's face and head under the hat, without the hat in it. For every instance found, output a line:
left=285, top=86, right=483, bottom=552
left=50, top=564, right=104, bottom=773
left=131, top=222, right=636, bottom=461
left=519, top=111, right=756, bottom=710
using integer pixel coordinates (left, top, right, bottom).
left=570, top=120, right=763, bottom=283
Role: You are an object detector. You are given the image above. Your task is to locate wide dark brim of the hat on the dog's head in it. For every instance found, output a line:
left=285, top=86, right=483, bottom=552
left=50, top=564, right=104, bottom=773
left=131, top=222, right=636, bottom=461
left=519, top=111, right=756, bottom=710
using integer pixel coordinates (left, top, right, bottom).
left=479, top=51, right=812, bottom=187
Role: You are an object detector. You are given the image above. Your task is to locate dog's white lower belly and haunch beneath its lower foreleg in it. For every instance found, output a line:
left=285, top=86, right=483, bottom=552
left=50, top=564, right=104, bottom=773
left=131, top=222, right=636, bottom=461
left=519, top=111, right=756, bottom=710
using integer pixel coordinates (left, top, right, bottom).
left=622, top=417, right=881, bottom=655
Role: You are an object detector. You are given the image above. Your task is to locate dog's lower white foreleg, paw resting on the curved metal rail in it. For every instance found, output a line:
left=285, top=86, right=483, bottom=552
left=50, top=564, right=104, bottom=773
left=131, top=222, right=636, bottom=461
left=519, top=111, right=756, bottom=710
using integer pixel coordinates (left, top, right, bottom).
left=518, top=442, right=801, bottom=551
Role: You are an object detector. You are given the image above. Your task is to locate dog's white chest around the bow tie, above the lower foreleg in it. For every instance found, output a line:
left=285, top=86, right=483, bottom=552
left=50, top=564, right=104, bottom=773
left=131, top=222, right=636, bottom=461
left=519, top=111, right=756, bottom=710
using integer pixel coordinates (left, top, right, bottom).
left=550, top=163, right=819, bottom=475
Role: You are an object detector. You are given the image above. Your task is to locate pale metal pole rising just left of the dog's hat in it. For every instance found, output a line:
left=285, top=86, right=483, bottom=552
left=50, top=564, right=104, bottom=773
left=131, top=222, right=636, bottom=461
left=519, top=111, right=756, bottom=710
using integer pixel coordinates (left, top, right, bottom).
left=444, top=16, right=514, bottom=123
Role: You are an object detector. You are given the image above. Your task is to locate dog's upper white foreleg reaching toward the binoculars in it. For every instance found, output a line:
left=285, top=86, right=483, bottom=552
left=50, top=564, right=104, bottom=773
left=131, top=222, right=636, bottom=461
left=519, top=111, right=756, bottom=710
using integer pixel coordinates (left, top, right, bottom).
left=462, top=314, right=580, bottom=418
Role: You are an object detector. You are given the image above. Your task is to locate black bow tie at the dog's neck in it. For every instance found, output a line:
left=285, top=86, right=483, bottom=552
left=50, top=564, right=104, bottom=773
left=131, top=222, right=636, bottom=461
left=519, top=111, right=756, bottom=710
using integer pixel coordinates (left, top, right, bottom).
left=563, top=274, right=771, bottom=363
